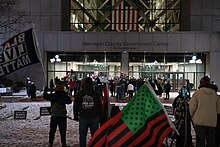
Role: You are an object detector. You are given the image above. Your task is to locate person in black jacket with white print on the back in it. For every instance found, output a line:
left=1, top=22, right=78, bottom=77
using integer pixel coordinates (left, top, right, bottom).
left=73, top=77, right=102, bottom=147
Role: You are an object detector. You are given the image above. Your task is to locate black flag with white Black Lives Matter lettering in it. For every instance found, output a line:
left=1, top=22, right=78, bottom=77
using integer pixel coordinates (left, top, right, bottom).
left=0, top=28, right=40, bottom=77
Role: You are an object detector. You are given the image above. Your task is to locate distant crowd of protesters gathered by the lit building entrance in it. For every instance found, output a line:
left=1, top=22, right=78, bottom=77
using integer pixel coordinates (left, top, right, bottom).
left=46, top=77, right=177, bottom=102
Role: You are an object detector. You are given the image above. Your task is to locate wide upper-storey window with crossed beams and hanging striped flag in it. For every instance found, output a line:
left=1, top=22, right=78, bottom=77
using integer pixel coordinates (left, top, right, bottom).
left=69, top=0, right=180, bottom=32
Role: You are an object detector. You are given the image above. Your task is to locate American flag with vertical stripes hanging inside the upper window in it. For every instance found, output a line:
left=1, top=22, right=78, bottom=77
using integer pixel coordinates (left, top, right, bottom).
left=111, top=0, right=138, bottom=31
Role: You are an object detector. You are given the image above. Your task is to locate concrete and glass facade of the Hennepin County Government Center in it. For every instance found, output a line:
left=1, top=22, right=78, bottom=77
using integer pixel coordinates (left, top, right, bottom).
left=3, top=0, right=220, bottom=91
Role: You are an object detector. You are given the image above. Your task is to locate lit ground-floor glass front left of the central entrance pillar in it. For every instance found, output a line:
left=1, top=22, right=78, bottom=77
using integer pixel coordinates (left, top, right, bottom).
left=48, top=52, right=121, bottom=84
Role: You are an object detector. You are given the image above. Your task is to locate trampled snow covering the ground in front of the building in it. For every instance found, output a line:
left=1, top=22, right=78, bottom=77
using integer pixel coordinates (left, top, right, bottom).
left=0, top=91, right=195, bottom=147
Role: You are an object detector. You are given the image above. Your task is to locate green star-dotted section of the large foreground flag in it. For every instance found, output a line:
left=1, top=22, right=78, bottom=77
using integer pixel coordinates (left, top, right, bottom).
left=121, top=84, right=162, bottom=133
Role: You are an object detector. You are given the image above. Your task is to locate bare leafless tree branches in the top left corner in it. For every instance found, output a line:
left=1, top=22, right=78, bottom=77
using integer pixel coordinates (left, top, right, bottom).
left=0, top=0, right=31, bottom=34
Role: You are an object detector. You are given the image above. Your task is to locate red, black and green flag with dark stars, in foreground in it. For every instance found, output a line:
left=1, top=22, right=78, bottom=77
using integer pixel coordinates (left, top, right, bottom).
left=89, top=84, right=174, bottom=147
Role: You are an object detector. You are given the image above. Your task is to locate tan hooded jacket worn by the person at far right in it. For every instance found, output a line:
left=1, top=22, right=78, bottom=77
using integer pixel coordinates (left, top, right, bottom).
left=189, top=84, right=220, bottom=127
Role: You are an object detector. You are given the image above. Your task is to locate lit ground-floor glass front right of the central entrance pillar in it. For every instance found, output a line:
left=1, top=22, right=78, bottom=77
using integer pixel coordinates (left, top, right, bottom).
left=129, top=52, right=206, bottom=91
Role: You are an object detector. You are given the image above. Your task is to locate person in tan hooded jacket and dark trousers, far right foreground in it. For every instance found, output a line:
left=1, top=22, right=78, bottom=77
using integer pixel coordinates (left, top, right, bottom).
left=189, top=76, right=220, bottom=147
